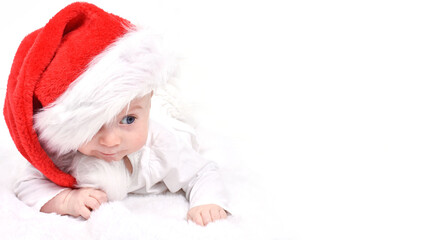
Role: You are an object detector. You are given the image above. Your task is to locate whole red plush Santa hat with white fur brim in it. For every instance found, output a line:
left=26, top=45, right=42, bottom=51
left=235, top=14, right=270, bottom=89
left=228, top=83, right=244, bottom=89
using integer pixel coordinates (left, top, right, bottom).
left=4, top=2, right=167, bottom=187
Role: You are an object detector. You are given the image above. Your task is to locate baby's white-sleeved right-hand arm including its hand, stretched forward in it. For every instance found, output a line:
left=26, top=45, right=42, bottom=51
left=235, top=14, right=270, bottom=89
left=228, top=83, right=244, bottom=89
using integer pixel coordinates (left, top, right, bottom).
left=146, top=121, right=229, bottom=226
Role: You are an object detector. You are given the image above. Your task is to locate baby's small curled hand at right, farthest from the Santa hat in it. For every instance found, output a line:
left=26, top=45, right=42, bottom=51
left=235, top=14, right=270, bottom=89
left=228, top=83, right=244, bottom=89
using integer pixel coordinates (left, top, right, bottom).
left=187, top=204, right=228, bottom=226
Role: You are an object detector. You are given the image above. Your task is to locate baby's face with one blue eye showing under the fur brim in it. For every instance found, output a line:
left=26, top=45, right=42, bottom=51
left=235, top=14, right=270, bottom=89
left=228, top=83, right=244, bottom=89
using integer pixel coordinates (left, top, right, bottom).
left=78, top=93, right=152, bottom=162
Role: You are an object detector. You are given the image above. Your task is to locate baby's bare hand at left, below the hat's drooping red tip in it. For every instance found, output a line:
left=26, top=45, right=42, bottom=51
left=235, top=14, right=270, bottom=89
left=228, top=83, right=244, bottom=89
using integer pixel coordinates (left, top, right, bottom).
left=40, top=188, right=108, bottom=219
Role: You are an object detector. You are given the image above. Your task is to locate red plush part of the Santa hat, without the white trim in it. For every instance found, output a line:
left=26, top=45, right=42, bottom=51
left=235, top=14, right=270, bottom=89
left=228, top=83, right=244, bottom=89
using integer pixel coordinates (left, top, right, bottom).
left=3, top=3, right=131, bottom=187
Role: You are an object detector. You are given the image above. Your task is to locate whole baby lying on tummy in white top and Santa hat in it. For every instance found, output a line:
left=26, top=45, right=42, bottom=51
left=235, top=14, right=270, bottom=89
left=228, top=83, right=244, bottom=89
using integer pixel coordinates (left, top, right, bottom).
left=4, top=2, right=228, bottom=225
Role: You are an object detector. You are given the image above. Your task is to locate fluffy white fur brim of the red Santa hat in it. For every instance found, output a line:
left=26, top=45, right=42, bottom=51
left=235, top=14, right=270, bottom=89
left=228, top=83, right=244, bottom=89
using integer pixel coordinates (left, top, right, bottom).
left=34, top=25, right=174, bottom=155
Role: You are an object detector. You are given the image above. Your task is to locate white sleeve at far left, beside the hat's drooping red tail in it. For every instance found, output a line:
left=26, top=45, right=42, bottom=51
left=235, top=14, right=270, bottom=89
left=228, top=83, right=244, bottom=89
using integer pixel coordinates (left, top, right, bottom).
left=14, top=163, right=66, bottom=211
